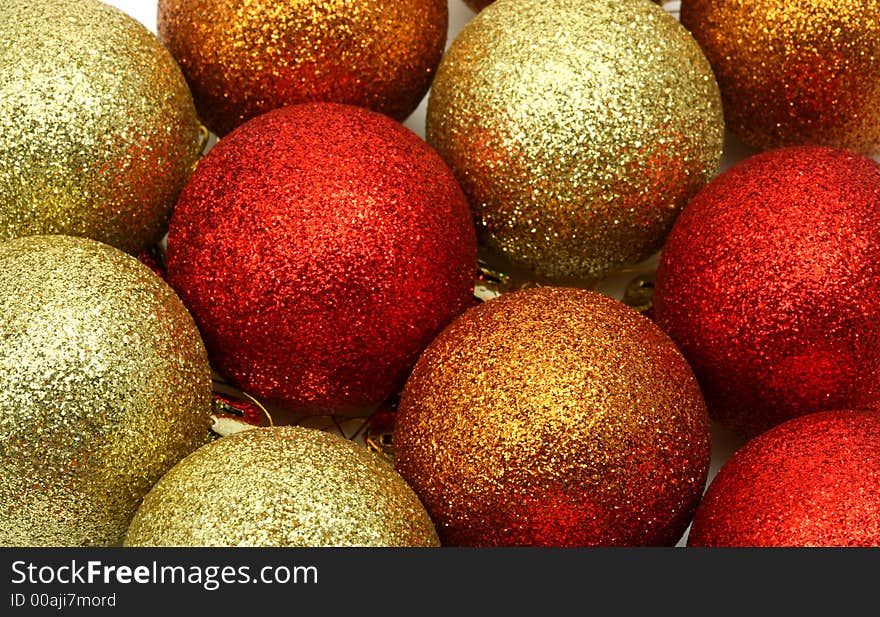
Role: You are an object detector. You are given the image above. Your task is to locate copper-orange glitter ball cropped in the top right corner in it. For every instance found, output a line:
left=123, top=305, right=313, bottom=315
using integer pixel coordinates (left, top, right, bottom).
left=681, top=0, right=880, bottom=154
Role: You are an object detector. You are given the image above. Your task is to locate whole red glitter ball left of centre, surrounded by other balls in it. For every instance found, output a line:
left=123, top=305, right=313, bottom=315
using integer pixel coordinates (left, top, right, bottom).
left=166, top=103, right=477, bottom=414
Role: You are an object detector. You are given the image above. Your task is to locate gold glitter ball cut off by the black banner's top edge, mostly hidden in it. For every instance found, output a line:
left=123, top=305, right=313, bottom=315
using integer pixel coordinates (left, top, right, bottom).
left=125, top=426, right=439, bottom=547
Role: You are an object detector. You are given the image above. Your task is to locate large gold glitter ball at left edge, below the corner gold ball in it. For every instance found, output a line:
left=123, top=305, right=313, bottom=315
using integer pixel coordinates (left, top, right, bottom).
left=0, top=236, right=211, bottom=546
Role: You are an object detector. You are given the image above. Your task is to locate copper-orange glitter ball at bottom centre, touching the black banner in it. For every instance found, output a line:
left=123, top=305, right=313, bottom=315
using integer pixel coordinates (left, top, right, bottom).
left=392, top=287, right=710, bottom=546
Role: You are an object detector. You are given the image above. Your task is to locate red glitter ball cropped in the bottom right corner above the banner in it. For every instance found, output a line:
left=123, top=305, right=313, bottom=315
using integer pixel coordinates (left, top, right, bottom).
left=688, top=411, right=880, bottom=546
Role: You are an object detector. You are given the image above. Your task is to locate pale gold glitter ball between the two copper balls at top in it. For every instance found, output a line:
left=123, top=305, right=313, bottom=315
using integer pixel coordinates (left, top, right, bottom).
left=426, top=0, right=724, bottom=283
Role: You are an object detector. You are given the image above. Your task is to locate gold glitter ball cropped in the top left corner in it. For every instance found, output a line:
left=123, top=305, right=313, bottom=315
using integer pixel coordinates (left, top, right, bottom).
left=0, top=0, right=207, bottom=254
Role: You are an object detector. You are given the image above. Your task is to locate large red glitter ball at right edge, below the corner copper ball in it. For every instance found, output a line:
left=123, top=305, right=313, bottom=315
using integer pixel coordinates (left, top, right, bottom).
left=654, top=146, right=880, bottom=436
